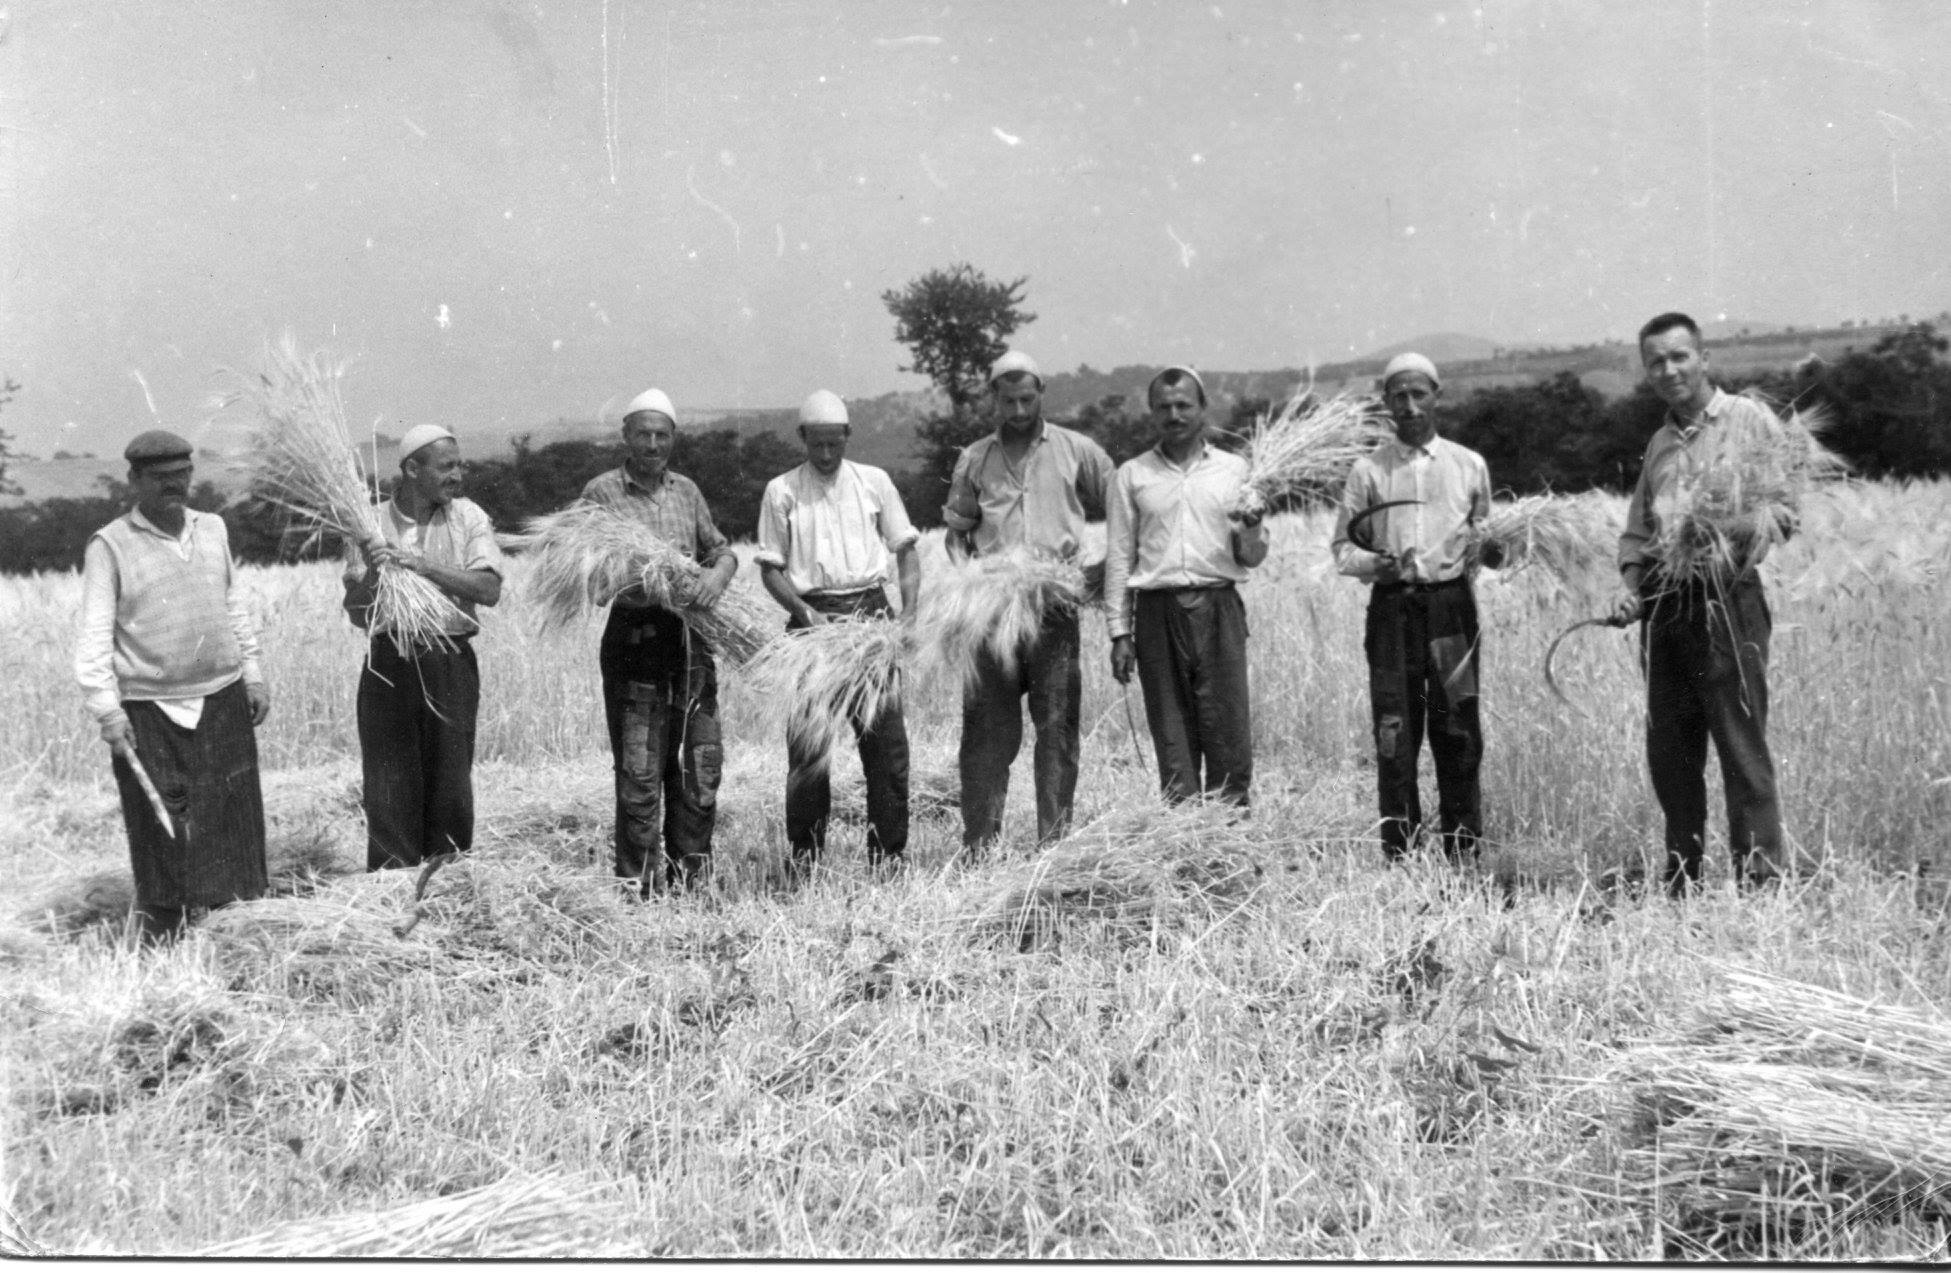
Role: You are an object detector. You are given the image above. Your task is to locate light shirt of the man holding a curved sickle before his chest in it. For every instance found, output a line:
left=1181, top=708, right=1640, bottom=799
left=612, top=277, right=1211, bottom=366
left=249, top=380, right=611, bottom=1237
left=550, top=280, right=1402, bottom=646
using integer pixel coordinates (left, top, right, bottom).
left=1333, top=437, right=1491, bottom=584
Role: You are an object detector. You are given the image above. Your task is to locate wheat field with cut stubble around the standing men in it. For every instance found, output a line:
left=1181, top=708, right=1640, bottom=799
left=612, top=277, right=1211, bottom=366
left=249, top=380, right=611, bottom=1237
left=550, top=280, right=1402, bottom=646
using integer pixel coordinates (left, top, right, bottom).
left=0, top=484, right=1951, bottom=1259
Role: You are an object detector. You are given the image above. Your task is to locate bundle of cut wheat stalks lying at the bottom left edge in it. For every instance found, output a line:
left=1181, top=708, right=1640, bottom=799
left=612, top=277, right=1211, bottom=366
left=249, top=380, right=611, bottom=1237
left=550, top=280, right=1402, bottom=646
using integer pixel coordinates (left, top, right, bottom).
left=197, top=1175, right=646, bottom=1259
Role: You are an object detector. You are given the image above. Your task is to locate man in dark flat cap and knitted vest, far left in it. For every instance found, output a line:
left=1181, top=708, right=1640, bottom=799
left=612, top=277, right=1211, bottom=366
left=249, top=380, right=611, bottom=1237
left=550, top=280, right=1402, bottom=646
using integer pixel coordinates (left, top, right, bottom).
left=74, top=430, right=271, bottom=941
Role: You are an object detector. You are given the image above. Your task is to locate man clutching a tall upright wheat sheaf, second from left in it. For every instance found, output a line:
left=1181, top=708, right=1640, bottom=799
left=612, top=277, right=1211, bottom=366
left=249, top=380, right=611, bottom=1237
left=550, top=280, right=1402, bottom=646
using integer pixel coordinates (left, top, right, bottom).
left=343, top=424, right=501, bottom=871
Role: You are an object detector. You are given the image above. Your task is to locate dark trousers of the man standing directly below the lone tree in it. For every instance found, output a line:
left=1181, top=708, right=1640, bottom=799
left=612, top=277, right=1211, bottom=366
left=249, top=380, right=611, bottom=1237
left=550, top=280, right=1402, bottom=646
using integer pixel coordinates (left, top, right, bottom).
left=958, top=611, right=1083, bottom=849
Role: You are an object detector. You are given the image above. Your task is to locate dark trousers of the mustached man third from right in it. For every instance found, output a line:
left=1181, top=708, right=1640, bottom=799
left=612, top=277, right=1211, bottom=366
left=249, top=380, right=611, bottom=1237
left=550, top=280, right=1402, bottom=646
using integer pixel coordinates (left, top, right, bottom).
left=1132, top=586, right=1253, bottom=804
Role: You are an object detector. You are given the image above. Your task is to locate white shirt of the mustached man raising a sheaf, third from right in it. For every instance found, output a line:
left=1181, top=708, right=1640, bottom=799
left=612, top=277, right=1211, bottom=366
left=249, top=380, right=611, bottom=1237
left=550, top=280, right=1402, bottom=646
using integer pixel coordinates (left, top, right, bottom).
left=1104, top=443, right=1247, bottom=637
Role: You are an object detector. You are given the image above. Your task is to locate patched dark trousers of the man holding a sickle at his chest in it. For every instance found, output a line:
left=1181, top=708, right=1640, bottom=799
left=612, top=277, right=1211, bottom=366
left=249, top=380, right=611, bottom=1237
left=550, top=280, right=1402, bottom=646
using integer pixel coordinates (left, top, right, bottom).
left=1366, top=580, right=1483, bottom=861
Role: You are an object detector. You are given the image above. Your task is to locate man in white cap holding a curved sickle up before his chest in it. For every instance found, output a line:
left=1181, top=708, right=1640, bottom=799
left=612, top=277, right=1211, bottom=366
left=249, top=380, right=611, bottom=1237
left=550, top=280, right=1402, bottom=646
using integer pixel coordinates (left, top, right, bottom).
left=1333, top=353, right=1502, bottom=863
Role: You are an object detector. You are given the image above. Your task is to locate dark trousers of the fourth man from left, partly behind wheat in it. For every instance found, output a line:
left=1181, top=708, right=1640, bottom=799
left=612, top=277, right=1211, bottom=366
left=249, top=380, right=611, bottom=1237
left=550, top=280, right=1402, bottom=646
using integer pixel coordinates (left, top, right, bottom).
left=786, top=588, right=907, bottom=865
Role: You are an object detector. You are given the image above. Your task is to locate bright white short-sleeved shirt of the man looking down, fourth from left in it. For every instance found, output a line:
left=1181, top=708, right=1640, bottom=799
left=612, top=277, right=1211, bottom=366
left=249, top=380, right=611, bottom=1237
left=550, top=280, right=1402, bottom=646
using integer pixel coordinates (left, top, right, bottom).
left=757, top=459, right=921, bottom=597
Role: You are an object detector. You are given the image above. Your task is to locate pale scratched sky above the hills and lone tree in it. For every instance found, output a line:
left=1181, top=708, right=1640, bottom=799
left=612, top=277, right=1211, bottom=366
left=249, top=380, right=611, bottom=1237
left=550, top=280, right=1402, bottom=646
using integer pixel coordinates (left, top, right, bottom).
left=0, top=0, right=1951, bottom=455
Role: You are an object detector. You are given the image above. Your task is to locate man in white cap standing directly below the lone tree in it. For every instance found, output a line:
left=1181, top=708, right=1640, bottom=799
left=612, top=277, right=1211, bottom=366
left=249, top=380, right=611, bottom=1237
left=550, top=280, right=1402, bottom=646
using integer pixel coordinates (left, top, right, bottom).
left=942, top=349, right=1112, bottom=857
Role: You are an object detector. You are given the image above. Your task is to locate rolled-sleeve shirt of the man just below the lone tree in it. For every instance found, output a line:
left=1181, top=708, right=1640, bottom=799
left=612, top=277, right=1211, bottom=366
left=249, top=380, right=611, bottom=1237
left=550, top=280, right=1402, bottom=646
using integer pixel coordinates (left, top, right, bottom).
left=942, top=420, right=1112, bottom=558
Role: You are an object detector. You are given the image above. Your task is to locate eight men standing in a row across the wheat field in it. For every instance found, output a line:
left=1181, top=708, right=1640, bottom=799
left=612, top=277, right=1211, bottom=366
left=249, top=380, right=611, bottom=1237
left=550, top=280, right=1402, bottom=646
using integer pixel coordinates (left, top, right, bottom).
left=76, top=314, right=1793, bottom=937
